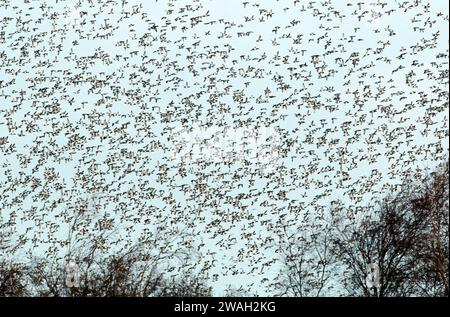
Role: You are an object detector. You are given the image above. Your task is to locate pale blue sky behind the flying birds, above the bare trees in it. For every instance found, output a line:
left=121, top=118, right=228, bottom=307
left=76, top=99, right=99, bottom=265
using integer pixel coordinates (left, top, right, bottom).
left=0, top=0, right=448, bottom=295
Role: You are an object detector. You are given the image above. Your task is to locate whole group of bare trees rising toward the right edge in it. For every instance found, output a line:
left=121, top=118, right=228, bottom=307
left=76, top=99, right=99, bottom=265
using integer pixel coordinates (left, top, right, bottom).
left=273, top=161, right=449, bottom=297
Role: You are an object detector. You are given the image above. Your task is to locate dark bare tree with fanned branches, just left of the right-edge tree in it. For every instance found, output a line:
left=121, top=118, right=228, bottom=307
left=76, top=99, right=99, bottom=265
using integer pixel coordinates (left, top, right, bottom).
left=333, top=196, right=424, bottom=297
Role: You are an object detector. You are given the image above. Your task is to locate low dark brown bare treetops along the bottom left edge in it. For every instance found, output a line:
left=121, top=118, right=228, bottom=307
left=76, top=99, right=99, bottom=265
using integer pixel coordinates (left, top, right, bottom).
left=0, top=239, right=211, bottom=297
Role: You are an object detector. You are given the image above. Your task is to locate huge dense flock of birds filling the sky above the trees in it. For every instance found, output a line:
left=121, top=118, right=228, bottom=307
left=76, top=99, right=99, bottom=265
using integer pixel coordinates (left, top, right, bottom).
left=0, top=0, right=449, bottom=294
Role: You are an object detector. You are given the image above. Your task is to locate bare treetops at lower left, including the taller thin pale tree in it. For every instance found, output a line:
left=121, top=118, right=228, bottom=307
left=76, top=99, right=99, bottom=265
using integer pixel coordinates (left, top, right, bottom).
left=0, top=190, right=211, bottom=297
